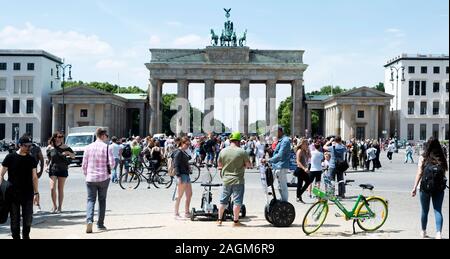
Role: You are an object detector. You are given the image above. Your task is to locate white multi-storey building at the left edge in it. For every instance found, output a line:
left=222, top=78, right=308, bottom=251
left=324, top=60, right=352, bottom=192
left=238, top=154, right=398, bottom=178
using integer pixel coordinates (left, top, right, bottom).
left=0, top=50, right=62, bottom=143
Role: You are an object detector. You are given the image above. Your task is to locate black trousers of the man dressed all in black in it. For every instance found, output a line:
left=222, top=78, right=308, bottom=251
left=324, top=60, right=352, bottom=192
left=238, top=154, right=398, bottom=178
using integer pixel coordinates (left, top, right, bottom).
left=10, top=198, right=33, bottom=239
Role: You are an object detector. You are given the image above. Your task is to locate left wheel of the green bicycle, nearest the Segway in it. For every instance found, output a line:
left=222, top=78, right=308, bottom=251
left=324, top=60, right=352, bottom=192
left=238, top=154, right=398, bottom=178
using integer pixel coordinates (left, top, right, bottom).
left=302, top=201, right=328, bottom=236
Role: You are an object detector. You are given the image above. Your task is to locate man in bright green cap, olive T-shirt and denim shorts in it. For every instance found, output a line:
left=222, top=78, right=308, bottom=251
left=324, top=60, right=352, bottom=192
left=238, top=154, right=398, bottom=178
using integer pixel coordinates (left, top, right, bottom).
left=218, top=132, right=251, bottom=227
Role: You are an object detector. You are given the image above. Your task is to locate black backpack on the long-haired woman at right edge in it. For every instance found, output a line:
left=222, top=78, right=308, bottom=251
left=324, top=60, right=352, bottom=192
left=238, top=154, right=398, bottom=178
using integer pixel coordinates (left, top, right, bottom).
left=420, top=164, right=447, bottom=194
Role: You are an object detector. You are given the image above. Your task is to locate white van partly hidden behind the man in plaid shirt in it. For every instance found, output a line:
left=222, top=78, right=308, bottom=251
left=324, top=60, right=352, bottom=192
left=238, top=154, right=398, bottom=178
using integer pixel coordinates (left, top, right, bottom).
left=66, top=126, right=108, bottom=166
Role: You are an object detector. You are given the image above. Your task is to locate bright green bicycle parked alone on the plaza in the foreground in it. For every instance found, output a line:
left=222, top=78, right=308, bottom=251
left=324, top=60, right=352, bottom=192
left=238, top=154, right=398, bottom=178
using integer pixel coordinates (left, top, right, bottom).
left=303, top=180, right=389, bottom=235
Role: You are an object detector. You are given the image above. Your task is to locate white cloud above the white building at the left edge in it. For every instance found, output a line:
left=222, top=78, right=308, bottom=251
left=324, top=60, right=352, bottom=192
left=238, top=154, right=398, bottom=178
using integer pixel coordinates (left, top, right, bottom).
left=0, top=23, right=113, bottom=59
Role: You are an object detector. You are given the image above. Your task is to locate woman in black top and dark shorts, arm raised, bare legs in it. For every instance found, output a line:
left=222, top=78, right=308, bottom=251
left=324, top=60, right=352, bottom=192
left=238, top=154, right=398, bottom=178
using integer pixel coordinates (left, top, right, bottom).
left=47, top=132, right=75, bottom=213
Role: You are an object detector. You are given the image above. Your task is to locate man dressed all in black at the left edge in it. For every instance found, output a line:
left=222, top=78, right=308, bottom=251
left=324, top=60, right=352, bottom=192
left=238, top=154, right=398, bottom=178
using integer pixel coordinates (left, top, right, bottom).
left=0, top=136, right=39, bottom=239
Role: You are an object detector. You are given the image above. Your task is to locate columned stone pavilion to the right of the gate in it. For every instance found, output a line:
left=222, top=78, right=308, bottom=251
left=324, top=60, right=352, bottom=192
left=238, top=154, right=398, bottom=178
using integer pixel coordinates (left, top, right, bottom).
left=306, top=87, right=393, bottom=140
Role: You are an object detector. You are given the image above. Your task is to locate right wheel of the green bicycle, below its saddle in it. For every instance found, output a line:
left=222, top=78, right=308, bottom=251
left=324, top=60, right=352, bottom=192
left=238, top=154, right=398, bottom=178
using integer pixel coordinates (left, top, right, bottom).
left=355, top=197, right=389, bottom=232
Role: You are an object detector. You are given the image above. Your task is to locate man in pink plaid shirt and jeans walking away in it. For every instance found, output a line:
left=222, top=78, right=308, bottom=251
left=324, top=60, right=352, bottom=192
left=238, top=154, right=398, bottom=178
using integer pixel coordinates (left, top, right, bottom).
left=82, top=128, right=115, bottom=234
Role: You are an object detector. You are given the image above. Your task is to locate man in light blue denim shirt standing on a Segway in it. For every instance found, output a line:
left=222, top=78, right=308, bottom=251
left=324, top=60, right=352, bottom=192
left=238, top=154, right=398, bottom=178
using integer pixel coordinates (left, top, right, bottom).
left=262, top=126, right=291, bottom=201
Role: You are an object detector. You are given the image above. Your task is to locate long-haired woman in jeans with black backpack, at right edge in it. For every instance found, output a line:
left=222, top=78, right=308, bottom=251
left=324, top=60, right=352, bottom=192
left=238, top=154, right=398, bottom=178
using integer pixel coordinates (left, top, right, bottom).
left=411, top=137, right=448, bottom=239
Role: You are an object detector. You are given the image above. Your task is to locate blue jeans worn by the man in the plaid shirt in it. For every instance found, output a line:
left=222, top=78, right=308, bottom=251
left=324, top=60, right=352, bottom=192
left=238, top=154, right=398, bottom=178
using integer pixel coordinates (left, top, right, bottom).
left=86, top=180, right=109, bottom=227
